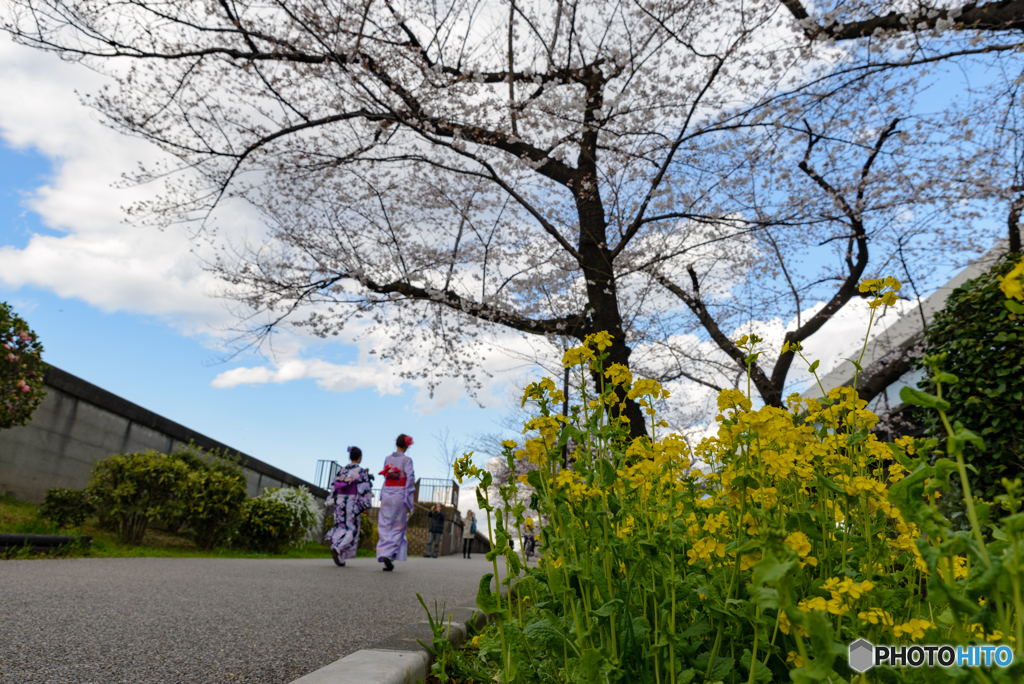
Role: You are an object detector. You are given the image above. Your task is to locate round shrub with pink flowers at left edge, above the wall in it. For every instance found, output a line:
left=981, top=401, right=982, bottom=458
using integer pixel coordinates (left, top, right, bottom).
left=0, top=302, right=46, bottom=430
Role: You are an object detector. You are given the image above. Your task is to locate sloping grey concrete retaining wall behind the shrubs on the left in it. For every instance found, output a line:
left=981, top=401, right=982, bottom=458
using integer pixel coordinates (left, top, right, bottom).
left=0, top=367, right=327, bottom=503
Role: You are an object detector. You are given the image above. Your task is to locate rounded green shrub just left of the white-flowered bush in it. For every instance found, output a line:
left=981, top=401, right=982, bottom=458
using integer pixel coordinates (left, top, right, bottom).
left=179, top=469, right=248, bottom=550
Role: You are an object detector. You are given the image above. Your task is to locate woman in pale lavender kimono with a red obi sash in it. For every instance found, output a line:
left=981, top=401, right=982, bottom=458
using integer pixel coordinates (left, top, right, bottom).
left=377, top=434, right=416, bottom=572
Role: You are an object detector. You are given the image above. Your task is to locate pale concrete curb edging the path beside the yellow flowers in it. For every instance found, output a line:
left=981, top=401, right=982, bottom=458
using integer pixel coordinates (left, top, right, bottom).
left=292, top=606, right=489, bottom=684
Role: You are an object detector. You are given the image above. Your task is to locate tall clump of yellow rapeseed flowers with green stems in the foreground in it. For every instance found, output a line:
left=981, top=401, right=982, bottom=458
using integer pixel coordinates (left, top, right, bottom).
left=456, top=279, right=1024, bottom=684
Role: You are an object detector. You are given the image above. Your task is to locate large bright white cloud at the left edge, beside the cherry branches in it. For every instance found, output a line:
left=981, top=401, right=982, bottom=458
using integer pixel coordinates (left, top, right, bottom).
left=0, top=42, right=237, bottom=334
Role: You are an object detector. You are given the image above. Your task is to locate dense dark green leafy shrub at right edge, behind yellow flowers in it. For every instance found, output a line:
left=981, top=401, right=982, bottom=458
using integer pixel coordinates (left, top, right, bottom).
left=919, top=254, right=1024, bottom=499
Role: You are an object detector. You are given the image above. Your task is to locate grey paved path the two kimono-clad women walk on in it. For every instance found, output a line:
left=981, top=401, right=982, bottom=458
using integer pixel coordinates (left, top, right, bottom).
left=0, top=554, right=490, bottom=684
